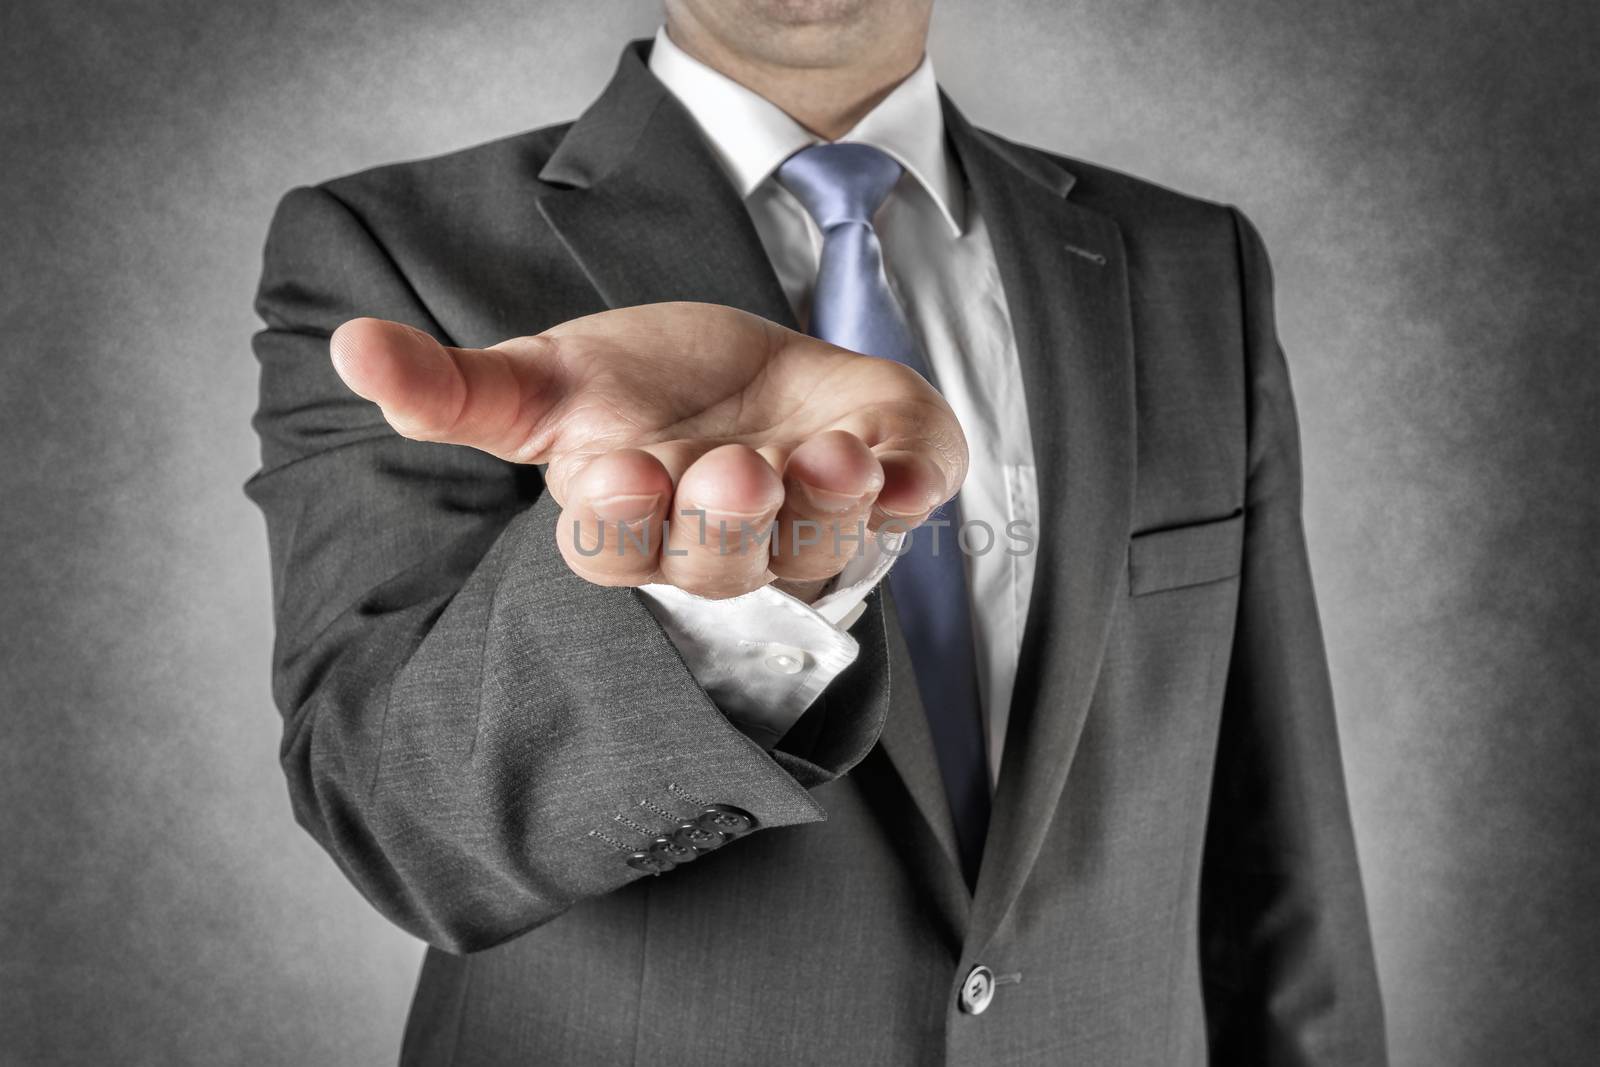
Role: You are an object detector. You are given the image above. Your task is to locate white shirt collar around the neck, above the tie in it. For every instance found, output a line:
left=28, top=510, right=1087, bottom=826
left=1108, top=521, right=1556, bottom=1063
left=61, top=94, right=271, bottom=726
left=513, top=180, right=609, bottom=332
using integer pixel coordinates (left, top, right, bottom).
left=650, top=27, right=965, bottom=235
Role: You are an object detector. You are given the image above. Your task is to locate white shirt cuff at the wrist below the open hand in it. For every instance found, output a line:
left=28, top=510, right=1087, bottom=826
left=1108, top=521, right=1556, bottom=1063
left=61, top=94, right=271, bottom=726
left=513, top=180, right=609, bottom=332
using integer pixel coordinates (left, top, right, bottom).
left=638, top=534, right=904, bottom=749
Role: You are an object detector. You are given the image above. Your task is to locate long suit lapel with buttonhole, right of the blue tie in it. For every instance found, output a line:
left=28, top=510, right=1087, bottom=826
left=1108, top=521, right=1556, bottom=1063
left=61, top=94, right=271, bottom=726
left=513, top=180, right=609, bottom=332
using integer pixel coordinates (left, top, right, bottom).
left=946, top=101, right=1134, bottom=952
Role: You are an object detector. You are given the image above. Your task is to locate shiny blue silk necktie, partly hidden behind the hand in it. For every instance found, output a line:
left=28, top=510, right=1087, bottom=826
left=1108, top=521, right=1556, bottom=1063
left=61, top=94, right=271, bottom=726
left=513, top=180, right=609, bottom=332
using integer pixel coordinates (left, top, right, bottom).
left=778, top=144, right=989, bottom=885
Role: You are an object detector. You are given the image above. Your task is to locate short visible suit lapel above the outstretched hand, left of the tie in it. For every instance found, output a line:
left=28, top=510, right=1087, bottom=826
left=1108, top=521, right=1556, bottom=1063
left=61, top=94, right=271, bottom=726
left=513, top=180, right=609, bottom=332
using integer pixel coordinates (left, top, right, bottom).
left=539, top=43, right=795, bottom=328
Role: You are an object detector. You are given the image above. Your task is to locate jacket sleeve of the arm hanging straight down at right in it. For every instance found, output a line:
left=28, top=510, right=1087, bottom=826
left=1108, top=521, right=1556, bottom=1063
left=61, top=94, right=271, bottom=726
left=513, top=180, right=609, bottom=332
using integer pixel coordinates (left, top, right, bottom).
left=1202, top=213, right=1386, bottom=1067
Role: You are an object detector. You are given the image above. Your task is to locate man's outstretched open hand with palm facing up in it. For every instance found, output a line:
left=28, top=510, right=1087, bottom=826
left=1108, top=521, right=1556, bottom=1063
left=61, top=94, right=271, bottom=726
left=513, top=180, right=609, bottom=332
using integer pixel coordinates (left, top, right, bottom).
left=331, top=304, right=966, bottom=600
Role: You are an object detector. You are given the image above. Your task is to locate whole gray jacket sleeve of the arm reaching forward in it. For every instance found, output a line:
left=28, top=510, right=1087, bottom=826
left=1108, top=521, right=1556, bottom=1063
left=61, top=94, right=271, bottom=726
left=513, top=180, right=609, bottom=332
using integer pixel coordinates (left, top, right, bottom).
left=246, top=187, right=886, bottom=952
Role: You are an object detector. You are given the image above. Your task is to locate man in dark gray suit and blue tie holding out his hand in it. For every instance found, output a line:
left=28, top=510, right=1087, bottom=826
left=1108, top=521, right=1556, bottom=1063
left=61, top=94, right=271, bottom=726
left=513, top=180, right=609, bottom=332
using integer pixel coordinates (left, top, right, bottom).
left=248, top=0, right=1384, bottom=1065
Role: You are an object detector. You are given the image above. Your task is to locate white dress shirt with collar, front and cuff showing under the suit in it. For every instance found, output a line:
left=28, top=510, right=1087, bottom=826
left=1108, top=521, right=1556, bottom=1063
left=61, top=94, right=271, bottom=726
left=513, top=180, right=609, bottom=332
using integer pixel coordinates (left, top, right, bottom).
left=640, top=29, right=1038, bottom=784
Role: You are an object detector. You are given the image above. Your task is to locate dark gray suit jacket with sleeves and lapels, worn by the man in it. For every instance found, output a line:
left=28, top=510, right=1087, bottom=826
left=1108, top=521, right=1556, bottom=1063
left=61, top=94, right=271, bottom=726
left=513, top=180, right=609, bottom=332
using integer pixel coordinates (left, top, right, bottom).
left=248, top=43, right=1384, bottom=1065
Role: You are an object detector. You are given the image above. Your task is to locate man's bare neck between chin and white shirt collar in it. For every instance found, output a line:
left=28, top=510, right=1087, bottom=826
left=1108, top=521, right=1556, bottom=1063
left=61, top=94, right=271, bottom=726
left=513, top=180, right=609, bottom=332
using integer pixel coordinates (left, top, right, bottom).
left=667, top=18, right=923, bottom=141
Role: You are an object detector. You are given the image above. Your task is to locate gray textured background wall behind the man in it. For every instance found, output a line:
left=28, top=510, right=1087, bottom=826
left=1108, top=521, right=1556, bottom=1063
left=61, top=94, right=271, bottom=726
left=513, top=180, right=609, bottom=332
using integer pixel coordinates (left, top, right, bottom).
left=0, top=0, right=1600, bottom=1067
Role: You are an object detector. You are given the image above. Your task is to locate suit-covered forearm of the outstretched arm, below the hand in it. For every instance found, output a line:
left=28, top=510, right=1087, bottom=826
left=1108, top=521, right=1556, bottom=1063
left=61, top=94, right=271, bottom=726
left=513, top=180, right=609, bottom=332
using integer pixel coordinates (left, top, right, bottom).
left=265, top=476, right=822, bottom=950
